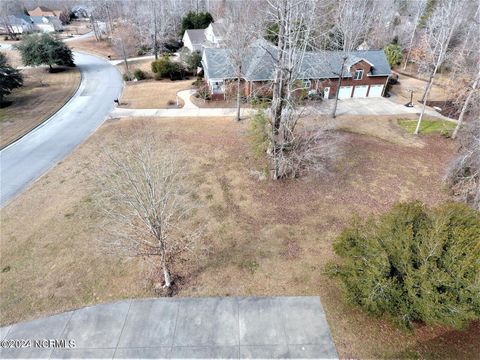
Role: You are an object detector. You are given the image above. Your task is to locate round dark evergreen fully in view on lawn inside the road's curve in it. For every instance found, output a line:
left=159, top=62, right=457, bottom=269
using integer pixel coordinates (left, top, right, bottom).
left=16, top=34, right=75, bottom=72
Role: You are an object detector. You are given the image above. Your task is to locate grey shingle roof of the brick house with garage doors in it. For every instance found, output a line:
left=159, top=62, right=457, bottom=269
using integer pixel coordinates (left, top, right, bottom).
left=203, top=40, right=390, bottom=81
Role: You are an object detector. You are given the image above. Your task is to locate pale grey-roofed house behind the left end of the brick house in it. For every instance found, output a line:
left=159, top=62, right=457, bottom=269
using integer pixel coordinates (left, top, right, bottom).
left=182, top=19, right=231, bottom=52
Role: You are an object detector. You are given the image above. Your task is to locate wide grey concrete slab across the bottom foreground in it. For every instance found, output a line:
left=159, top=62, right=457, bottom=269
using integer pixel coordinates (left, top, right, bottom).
left=0, top=297, right=337, bottom=359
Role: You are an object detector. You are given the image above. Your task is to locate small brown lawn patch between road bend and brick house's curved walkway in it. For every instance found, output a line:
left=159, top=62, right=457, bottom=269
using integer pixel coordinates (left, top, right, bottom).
left=120, top=79, right=194, bottom=109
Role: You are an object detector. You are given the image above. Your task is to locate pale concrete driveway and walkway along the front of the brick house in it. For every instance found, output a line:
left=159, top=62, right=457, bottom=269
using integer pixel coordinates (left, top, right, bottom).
left=110, top=95, right=456, bottom=121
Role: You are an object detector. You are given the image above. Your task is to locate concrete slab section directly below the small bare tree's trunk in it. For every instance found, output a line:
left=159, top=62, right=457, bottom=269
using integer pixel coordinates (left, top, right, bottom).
left=118, top=299, right=178, bottom=348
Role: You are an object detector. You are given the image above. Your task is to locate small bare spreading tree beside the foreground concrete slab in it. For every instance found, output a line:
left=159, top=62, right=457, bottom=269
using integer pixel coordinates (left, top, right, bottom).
left=96, top=129, right=200, bottom=288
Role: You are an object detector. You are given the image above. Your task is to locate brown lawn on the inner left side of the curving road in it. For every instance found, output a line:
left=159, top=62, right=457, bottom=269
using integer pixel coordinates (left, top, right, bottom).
left=0, top=68, right=80, bottom=148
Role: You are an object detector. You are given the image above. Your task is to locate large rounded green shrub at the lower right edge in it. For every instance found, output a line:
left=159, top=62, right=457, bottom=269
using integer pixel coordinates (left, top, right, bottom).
left=329, top=202, right=480, bottom=328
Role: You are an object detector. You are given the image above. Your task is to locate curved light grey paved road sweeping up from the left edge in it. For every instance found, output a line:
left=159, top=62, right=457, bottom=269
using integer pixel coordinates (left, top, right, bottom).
left=0, top=53, right=122, bottom=207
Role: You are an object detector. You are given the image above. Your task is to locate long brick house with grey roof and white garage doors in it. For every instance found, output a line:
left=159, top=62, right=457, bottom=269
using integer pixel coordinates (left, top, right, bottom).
left=202, top=40, right=390, bottom=99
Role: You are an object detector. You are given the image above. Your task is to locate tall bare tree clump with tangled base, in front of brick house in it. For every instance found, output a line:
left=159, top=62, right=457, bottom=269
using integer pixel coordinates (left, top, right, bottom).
left=267, top=0, right=333, bottom=179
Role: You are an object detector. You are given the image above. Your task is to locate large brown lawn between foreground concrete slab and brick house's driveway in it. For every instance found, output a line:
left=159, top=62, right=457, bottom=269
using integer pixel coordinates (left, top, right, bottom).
left=0, top=118, right=480, bottom=358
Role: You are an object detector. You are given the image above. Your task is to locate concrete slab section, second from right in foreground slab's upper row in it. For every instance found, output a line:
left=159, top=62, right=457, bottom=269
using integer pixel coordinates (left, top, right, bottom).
left=174, top=298, right=239, bottom=346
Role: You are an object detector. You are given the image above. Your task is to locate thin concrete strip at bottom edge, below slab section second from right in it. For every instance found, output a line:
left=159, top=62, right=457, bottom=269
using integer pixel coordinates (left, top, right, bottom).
left=170, top=346, right=239, bottom=359
